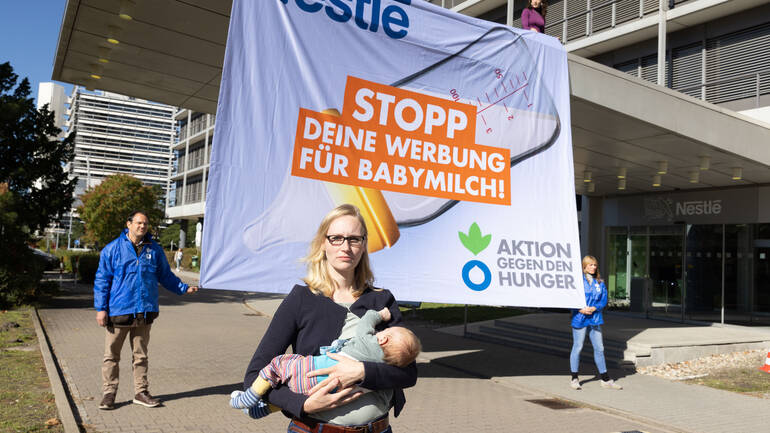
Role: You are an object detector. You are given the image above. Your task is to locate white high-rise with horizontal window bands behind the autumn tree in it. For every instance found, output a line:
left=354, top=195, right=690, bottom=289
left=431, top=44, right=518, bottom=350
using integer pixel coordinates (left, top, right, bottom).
left=67, top=86, right=176, bottom=204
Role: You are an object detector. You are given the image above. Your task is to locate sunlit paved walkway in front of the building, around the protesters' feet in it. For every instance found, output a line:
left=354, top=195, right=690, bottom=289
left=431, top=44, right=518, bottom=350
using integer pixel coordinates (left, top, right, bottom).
left=40, top=273, right=770, bottom=433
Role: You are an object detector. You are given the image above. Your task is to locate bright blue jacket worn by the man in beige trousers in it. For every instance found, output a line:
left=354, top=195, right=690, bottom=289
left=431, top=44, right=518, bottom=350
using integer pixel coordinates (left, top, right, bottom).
left=94, top=229, right=187, bottom=316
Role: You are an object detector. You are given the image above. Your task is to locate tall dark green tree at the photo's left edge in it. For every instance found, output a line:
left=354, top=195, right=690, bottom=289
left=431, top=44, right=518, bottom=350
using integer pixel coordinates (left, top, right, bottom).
left=0, top=62, right=77, bottom=304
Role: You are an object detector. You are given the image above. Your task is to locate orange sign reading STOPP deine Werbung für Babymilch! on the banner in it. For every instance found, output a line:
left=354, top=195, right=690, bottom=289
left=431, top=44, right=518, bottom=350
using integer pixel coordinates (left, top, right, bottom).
left=291, top=76, right=511, bottom=205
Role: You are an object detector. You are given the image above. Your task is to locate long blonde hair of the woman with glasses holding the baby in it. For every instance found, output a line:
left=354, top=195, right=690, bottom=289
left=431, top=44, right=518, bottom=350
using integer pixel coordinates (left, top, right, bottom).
left=302, top=204, right=374, bottom=298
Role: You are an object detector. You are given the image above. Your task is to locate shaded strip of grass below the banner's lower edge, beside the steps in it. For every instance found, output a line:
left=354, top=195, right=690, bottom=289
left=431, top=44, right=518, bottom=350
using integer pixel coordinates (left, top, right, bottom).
left=401, top=302, right=529, bottom=326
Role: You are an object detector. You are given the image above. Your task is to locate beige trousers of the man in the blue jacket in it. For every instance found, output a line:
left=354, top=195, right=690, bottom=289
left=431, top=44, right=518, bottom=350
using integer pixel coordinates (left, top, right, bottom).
left=102, top=325, right=152, bottom=394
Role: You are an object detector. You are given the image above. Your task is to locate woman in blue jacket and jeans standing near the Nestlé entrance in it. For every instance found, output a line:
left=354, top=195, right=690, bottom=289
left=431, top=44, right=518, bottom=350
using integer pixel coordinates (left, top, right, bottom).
left=569, top=256, right=623, bottom=389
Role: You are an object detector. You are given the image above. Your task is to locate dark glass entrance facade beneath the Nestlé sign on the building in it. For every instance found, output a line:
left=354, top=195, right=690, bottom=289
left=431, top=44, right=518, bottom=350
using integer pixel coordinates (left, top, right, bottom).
left=605, top=223, right=770, bottom=326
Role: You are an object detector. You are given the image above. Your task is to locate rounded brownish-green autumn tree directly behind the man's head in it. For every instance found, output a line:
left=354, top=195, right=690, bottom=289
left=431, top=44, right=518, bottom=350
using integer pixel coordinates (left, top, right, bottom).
left=78, top=174, right=165, bottom=246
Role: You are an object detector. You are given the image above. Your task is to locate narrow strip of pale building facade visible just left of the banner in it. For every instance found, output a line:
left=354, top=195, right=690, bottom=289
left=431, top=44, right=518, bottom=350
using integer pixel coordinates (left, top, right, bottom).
left=166, top=109, right=216, bottom=246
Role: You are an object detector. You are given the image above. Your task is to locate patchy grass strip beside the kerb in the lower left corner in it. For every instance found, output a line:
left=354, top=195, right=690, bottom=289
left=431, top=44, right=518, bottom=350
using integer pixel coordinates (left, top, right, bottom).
left=0, top=308, right=64, bottom=432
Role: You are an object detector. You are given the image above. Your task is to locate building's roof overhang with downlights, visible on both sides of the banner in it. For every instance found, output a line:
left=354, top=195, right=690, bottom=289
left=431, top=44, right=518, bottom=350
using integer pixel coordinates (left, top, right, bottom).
left=52, top=0, right=770, bottom=195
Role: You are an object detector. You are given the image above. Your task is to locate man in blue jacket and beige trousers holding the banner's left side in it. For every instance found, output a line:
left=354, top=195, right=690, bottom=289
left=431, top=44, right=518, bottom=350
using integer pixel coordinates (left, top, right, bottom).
left=94, top=211, right=198, bottom=409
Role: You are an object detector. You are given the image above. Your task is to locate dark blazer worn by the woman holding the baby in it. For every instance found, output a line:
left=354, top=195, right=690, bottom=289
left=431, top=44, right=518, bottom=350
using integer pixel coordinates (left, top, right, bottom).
left=243, top=285, right=417, bottom=418
